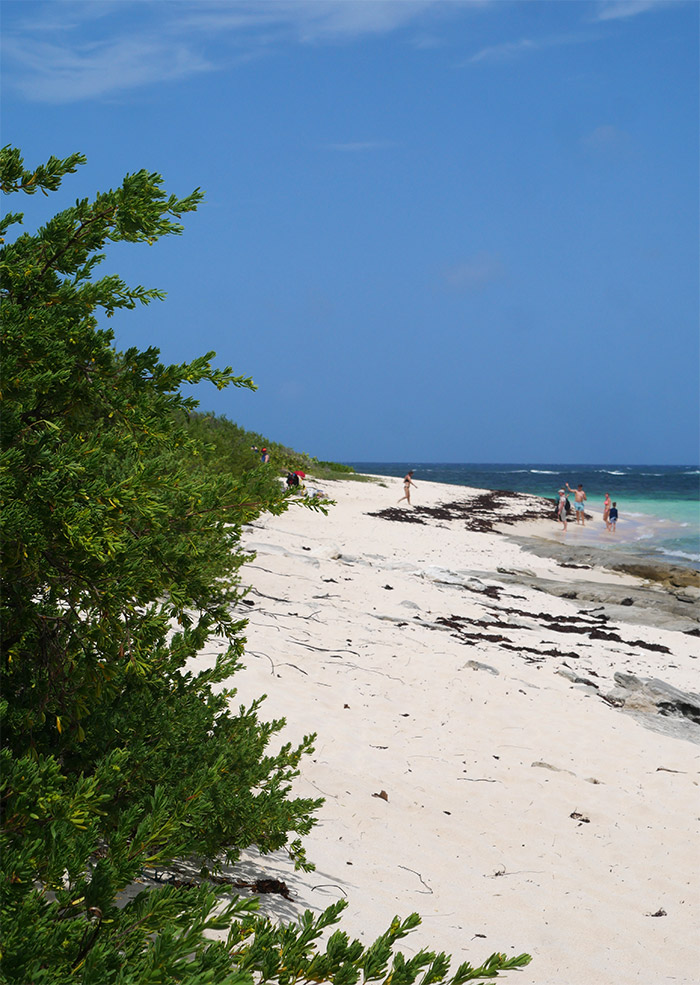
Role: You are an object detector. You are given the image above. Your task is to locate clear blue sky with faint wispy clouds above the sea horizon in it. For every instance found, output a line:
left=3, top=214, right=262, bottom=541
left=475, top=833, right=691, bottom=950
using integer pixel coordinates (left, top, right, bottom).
left=2, top=0, right=700, bottom=464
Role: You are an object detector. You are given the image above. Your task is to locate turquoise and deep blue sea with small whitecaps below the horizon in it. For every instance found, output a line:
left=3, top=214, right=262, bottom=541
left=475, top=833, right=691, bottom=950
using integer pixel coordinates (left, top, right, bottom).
left=346, top=462, right=700, bottom=569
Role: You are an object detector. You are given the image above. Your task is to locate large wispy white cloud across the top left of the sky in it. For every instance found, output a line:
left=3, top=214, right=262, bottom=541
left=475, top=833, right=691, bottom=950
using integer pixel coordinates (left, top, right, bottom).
left=3, top=0, right=482, bottom=103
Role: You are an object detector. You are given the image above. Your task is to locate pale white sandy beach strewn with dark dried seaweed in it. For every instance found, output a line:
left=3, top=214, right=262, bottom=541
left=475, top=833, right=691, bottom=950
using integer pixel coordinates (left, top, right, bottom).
left=202, top=479, right=700, bottom=985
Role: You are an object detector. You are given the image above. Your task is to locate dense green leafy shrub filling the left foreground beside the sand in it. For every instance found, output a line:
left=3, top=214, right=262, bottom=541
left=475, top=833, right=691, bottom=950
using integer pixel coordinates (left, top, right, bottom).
left=0, top=147, right=528, bottom=985
